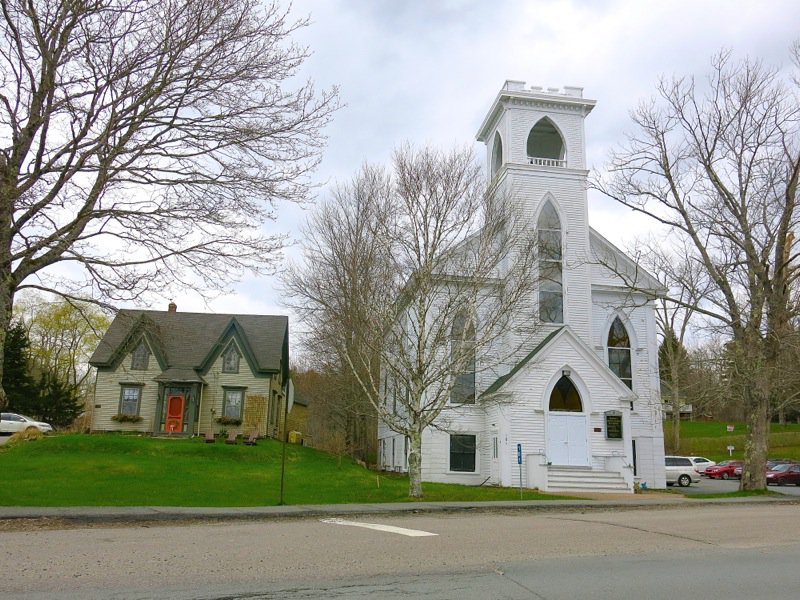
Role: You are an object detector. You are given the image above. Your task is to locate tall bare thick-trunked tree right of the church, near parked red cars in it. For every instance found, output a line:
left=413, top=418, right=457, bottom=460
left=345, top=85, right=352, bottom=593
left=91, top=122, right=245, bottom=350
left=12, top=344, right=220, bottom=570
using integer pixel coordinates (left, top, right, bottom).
left=596, top=46, right=800, bottom=489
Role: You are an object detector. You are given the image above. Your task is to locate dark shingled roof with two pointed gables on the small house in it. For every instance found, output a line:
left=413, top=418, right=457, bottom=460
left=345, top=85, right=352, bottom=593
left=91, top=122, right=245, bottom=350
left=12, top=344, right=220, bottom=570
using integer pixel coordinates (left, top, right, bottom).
left=89, top=309, right=289, bottom=377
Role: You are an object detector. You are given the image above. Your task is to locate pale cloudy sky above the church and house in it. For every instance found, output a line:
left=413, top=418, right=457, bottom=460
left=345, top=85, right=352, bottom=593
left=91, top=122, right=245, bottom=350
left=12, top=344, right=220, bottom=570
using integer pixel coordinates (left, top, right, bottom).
left=175, top=0, right=800, bottom=314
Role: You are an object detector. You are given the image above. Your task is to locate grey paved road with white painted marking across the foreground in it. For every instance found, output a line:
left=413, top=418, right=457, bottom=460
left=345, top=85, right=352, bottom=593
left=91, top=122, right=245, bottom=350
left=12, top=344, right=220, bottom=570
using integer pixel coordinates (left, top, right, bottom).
left=0, top=503, right=800, bottom=600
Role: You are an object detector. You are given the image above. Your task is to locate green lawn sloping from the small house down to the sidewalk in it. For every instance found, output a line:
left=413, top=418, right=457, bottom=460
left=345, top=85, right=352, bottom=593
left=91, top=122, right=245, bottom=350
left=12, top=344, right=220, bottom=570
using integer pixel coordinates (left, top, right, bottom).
left=0, top=434, right=576, bottom=506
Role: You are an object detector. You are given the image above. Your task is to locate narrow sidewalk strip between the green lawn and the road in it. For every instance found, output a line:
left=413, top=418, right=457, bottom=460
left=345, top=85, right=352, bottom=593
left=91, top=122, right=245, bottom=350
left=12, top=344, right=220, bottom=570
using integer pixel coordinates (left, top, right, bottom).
left=0, top=492, right=800, bottom=522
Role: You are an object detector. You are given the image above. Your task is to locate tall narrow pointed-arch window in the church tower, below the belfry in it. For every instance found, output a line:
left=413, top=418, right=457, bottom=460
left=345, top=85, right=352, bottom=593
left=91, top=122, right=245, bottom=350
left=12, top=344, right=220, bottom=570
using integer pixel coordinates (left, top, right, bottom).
left=536, top=200, right=564, bottom=323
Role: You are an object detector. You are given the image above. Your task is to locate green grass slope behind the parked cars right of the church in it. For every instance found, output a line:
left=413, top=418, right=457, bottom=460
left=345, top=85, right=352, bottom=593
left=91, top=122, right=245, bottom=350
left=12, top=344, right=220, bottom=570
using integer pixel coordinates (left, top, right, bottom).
left=664, top=421, right=800, bottom=461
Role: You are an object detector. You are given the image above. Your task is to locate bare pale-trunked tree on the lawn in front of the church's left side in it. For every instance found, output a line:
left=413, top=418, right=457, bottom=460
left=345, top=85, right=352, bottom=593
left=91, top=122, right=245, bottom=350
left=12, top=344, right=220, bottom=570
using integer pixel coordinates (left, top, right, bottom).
left=288, top=146, right=538, bottom=497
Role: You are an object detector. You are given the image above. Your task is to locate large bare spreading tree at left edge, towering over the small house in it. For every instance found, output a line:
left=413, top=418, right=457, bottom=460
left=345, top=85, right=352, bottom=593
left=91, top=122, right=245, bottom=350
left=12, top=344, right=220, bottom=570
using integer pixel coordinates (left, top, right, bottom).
left=0, top=0, right=336, bottom=405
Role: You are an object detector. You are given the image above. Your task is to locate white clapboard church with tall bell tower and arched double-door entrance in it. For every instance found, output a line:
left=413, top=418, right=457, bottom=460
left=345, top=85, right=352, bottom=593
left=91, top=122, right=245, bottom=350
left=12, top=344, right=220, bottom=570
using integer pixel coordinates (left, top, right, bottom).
left=378, top=81, right=665, bottom=492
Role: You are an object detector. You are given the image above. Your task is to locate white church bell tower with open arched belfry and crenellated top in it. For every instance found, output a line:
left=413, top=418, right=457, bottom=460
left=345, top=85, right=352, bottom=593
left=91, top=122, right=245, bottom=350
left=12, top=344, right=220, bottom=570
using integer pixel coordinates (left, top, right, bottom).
left=478, top=81, right=595, bottom=340
